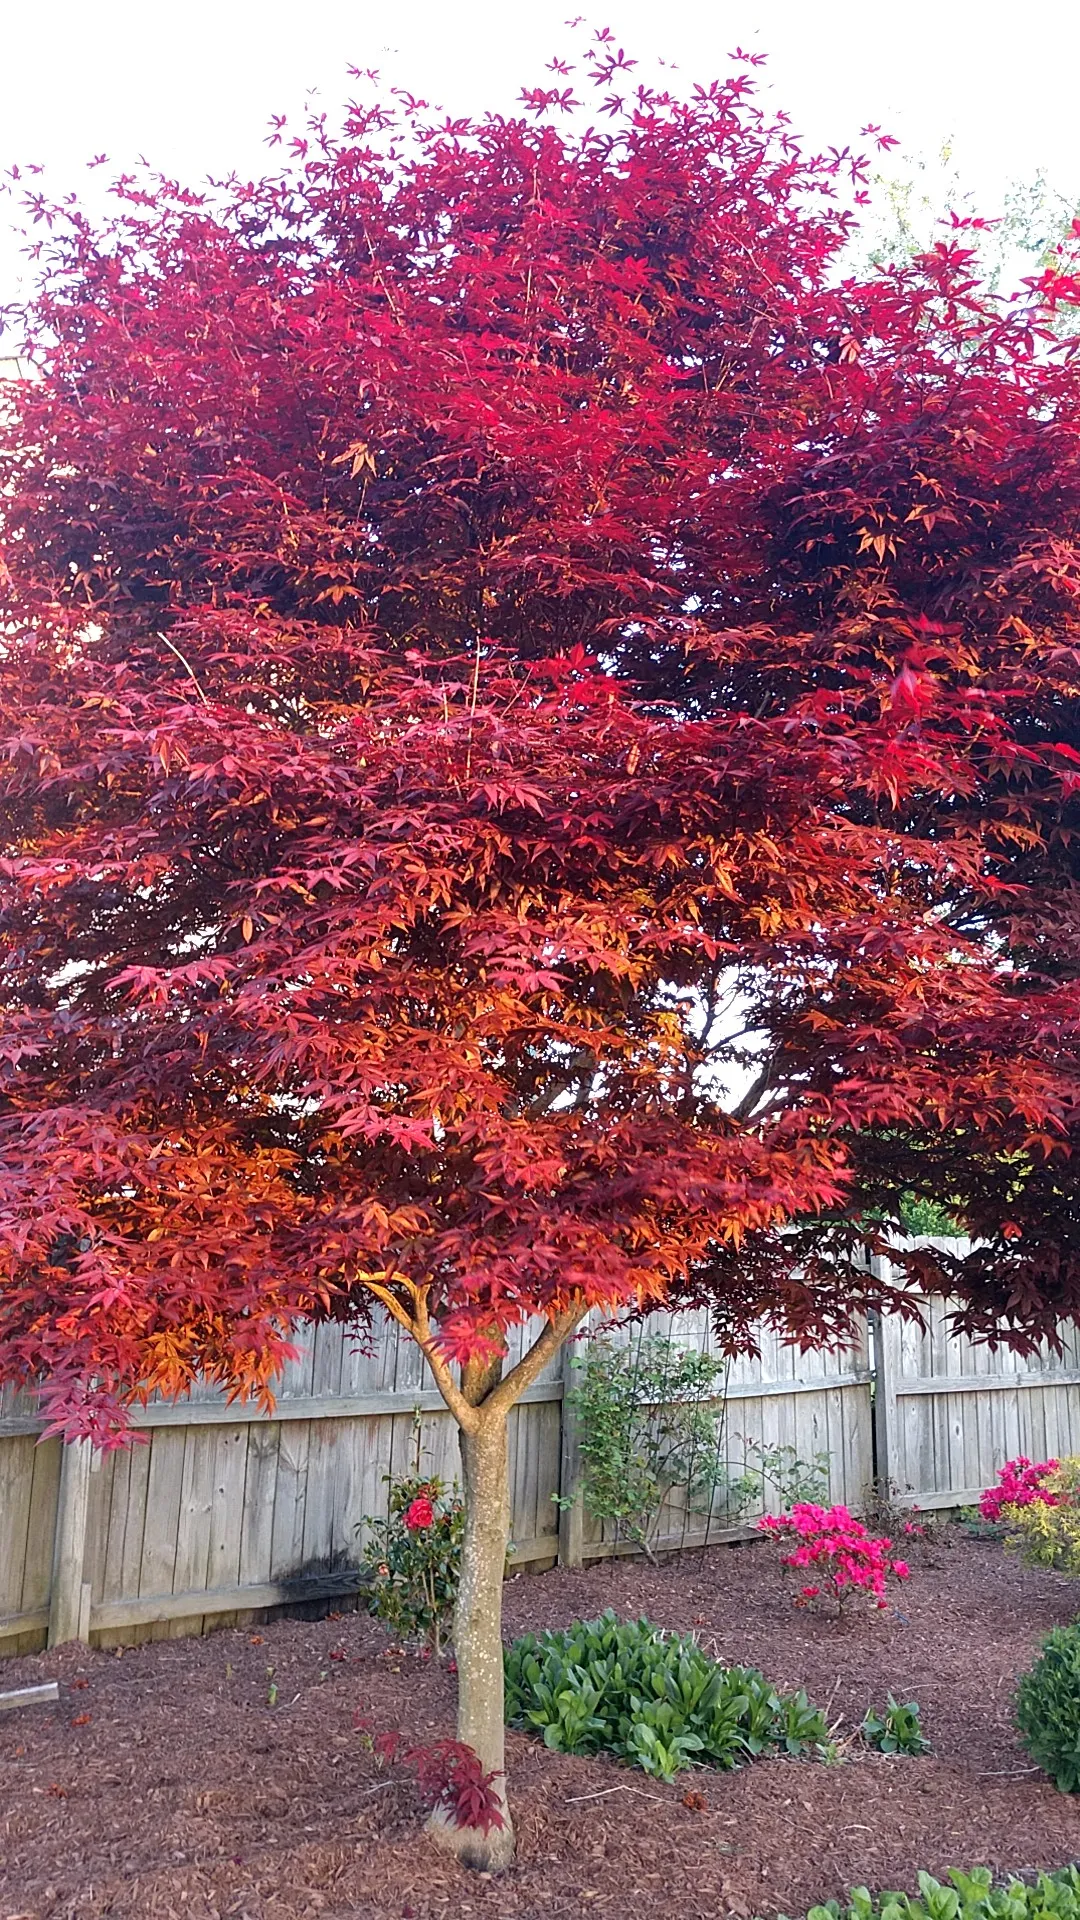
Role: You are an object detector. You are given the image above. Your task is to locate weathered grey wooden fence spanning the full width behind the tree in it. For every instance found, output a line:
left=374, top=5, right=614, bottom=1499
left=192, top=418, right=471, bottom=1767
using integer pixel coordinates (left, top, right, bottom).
left=0, top=1251, right=1080, bottom=1653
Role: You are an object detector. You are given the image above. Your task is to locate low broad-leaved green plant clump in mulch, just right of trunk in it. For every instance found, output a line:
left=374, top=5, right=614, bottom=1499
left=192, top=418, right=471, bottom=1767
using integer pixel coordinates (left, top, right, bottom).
left=505, top=1611, right=830, bottom=1780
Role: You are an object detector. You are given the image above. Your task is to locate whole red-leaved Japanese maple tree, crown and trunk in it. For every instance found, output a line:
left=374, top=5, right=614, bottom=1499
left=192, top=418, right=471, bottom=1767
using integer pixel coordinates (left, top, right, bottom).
left=0, top=35, right=1080, bottom=1862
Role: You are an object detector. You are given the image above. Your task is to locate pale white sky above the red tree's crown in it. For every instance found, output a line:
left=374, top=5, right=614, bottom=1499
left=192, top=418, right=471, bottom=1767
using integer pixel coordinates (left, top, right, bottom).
left=0, top=0, right=1080, bottom=318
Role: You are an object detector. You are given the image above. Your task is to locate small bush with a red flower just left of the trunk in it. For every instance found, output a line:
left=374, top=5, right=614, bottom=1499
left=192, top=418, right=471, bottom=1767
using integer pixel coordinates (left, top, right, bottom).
left=361, top=1475, right=465, bottom=1655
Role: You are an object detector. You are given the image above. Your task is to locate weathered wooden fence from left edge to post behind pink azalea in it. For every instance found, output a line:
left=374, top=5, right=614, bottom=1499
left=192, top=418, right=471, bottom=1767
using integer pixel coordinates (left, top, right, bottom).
left=0, top=1313, right=872, bottom=1653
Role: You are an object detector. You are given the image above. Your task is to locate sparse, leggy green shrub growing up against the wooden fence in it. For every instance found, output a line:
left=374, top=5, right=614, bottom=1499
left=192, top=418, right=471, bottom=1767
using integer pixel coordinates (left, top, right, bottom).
left=571, top=1336, right=726, bottom=1559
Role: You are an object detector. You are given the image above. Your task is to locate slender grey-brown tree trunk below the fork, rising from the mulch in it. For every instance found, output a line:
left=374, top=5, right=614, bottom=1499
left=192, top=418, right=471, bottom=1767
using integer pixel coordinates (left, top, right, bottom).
left=429, top=1407, right=513, bottom=1870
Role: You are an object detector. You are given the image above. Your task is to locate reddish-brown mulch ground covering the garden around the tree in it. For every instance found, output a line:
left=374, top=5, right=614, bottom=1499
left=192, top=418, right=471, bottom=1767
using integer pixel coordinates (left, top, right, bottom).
left=0, top=1528, right=1080, bottom=1920
